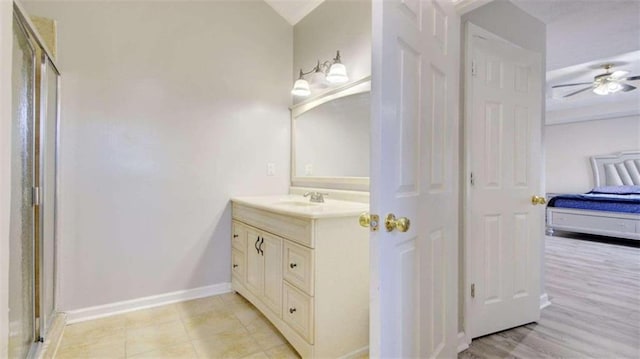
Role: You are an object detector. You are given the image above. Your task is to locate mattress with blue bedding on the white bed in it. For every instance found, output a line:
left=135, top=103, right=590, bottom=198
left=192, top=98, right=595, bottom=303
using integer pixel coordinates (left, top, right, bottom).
left=549, top=186, right=640, bottom=213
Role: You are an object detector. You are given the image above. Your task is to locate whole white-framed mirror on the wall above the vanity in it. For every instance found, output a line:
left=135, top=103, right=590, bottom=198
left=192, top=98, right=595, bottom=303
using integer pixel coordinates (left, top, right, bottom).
left=291, top=76, right=371, bottom=191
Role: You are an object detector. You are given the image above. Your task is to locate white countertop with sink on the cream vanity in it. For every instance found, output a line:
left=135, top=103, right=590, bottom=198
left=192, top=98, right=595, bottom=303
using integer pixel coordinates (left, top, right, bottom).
left=231, top=195, right=369, bottom=218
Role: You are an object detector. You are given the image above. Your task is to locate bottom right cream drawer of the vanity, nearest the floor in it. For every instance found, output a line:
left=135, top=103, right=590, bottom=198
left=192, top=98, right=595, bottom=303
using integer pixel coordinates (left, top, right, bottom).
left=282, top=282, right=313, bottom=344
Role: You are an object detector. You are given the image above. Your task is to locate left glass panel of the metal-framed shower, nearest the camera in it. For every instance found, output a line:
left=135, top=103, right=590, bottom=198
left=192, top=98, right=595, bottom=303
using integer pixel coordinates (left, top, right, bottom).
left=9, top=15, right=35, bottom=358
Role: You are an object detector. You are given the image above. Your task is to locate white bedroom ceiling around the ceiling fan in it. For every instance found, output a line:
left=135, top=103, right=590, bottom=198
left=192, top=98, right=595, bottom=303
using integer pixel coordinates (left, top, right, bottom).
left=511, top=0, right=640, bottom=124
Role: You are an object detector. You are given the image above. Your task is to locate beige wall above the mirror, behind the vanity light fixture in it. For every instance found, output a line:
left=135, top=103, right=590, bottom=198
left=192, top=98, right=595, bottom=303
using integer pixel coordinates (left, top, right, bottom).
left=292, top=0, right=371, bottom=101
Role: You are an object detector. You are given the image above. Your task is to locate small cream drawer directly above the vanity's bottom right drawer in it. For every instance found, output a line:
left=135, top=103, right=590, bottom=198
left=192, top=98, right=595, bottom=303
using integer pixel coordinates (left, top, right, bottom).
left=283, top=241, right=314, bottom=295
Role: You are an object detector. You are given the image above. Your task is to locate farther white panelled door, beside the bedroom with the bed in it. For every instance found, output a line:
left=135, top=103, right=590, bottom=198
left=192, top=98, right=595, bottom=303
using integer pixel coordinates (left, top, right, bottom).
left=466, top=24, right=544, bottom=338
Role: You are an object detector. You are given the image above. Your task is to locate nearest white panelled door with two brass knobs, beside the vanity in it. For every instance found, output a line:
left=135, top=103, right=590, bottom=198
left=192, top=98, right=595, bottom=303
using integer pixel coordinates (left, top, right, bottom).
left=370, top=0, right=460, bottom=358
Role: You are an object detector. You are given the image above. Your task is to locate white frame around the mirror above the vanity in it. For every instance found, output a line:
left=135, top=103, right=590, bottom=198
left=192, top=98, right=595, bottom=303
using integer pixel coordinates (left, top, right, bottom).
left=289, top=76, right=371, bottom=191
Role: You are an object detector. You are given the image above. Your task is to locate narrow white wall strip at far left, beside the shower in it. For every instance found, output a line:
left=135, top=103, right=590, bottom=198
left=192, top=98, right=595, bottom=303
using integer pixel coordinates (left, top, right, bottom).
left=0, top=0, right=13, bottom=358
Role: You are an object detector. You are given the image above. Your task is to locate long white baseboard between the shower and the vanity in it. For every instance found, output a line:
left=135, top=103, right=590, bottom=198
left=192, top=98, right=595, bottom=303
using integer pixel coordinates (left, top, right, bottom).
left=66, top=282, right=231, bottom=324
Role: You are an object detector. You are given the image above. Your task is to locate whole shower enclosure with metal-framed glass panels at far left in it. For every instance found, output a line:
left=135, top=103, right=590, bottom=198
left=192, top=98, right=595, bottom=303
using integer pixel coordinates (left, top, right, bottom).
left=8, top=6, right=60, bottom=358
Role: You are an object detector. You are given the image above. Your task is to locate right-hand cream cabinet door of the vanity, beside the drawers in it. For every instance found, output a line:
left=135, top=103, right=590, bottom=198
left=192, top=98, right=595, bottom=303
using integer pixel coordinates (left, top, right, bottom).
left=260, top=233, right=282, bottom=316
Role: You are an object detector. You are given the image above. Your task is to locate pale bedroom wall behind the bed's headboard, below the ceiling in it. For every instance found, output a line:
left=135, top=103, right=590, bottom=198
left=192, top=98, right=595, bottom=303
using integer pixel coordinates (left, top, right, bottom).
left=545, top=116, right=640, bottom=193
